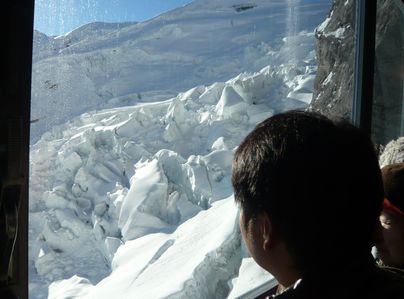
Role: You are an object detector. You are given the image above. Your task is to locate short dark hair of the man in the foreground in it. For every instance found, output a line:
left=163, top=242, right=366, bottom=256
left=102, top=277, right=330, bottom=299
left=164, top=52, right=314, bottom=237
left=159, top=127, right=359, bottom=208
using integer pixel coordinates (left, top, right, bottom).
left=232, top=111, right=383, bottom=273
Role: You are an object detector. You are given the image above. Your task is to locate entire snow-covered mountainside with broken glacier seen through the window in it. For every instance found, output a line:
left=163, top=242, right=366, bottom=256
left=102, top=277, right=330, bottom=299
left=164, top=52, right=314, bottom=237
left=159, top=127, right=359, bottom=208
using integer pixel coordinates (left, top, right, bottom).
left=29, top=0, right=330, bottom=298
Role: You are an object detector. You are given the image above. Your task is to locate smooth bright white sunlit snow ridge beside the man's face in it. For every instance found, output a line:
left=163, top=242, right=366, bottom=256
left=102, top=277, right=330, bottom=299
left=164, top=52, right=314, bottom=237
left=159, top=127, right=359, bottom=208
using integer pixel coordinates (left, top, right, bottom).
left=56, top=197, right=241, bottom=298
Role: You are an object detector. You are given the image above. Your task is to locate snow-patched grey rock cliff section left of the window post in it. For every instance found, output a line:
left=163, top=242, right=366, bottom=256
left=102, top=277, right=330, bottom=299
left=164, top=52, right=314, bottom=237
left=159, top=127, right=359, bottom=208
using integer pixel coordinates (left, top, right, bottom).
left=310, top=0, right=355, bottom=119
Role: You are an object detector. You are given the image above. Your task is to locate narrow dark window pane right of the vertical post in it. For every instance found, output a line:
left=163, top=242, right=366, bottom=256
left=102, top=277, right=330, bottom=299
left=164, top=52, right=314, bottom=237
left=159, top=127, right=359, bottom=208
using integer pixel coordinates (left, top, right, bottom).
left=372, top=0, right=404, bottom=146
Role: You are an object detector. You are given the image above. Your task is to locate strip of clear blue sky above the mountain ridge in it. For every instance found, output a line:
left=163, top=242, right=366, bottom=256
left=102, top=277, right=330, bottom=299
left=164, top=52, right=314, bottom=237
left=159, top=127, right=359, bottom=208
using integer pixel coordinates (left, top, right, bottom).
left=34, top=0, right=191, bottom=35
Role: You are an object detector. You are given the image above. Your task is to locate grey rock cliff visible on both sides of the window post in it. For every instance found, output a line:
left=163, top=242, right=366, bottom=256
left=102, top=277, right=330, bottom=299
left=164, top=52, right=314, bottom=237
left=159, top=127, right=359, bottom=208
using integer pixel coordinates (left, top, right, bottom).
left=310, top=0, right=404, bottom=144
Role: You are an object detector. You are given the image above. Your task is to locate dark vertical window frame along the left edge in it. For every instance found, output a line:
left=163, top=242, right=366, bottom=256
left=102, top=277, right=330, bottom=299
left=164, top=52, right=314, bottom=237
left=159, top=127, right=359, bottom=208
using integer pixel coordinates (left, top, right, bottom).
left=0, top=0, right=34, bottom=298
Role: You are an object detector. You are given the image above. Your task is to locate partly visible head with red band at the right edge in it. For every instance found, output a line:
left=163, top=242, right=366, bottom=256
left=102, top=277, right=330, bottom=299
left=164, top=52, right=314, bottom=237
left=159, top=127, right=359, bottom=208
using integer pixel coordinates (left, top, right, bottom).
left=376, top=163, right=404, bottom=268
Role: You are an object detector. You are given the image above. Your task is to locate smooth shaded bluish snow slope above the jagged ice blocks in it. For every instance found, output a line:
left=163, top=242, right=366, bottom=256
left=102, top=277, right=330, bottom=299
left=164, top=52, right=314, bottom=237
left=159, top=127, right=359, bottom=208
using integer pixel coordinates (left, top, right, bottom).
left=31, top=0, right=329, bottom=142
